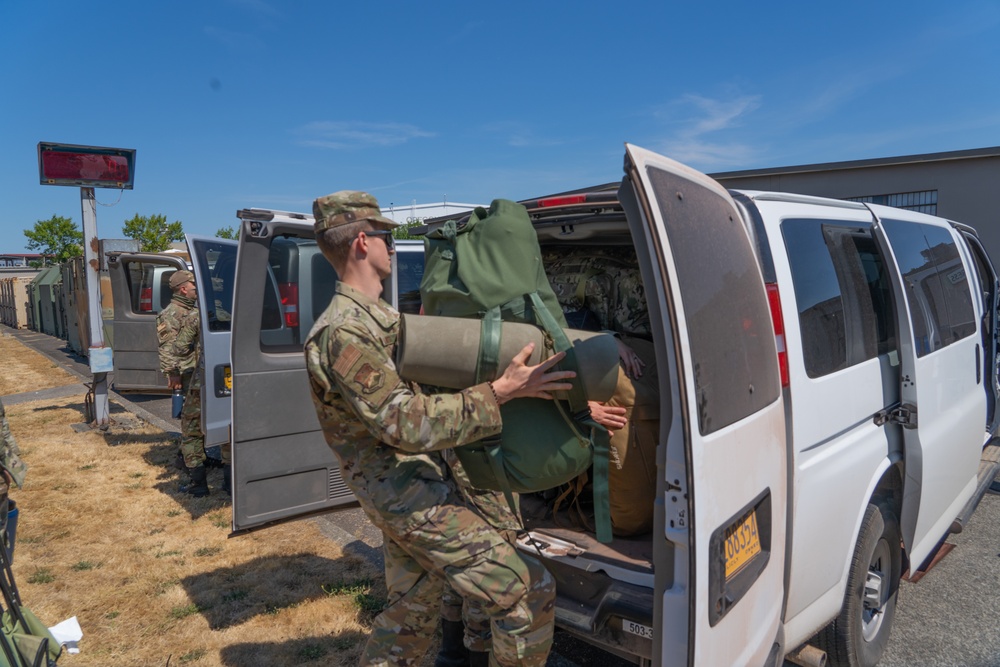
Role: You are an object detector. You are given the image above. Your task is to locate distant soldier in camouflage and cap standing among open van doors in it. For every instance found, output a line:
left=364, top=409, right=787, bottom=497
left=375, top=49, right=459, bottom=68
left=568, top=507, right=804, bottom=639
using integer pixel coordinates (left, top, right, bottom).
left=156, top=270, right=208, bottom=498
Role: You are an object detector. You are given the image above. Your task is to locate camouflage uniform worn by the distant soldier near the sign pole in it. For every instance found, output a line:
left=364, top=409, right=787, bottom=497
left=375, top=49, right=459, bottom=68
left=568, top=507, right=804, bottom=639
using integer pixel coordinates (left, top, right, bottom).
left=156, top=293, right=205, bottom=468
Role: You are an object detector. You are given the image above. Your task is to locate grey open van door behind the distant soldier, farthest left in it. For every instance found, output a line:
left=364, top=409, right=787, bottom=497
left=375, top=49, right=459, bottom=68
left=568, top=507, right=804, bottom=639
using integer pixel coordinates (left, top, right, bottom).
left=108, top=253, right=187, bottom=392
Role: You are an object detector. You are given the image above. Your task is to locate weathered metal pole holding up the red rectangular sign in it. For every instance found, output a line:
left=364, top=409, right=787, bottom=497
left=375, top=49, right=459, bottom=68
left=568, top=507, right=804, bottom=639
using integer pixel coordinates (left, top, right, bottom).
left=80, top=188, right=114, bottom=431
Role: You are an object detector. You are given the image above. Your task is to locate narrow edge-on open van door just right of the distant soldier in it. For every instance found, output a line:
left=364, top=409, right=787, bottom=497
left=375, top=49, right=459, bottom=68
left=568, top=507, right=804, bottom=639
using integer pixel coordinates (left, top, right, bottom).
left=187, top=234, right=237, bottom=447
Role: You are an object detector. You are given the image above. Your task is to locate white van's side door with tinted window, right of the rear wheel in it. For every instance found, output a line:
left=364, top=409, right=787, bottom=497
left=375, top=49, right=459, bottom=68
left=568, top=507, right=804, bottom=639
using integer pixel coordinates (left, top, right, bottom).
left=871, top=214, right=986, bottom=571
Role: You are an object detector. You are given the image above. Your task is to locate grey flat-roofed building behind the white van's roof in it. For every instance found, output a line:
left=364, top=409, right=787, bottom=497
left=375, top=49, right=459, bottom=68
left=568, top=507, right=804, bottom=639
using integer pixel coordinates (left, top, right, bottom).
left=711, top=146, right=1000, bottom=267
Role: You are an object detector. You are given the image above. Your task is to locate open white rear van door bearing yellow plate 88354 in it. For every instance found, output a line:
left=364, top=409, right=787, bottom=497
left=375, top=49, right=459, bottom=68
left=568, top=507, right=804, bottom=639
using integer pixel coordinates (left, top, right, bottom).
left=619, top=145, right=787, bottom=665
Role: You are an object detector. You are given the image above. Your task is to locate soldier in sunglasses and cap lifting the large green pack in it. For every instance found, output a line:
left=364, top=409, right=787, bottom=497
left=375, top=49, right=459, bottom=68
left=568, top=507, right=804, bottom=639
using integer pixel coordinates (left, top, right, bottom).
left=305, top=191, right=574, bottom=666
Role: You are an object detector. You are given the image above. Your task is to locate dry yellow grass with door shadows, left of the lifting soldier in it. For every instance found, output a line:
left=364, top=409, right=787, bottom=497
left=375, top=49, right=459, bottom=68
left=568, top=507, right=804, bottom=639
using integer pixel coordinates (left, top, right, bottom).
left=0, top=337, right=414, bottom=667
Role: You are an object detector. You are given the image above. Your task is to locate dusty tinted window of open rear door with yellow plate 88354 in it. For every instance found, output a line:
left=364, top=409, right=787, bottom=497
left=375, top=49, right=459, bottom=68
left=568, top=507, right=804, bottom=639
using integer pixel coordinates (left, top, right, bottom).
left=648, top=163, right=780, bottom=435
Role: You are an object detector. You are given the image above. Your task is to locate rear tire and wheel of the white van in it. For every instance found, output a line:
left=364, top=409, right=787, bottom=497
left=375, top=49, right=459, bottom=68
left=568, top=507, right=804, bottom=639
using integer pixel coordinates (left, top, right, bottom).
left=816, top=503, right=903, bottom=667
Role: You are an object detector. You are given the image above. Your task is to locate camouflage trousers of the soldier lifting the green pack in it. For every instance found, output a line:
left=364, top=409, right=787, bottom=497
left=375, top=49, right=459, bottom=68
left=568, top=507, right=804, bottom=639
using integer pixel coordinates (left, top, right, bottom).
left=361, top=498, right=555, bottom=667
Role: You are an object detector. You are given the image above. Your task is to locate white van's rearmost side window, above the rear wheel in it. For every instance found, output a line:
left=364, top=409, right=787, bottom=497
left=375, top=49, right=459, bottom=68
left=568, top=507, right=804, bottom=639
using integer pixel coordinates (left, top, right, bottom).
left=781, top=219, right=896, bottom=378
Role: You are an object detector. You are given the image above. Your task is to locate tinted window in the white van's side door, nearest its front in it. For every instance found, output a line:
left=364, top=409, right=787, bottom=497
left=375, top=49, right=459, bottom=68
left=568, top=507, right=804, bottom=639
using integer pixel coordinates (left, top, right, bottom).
left=881, top=219, right=976, bottom=357
